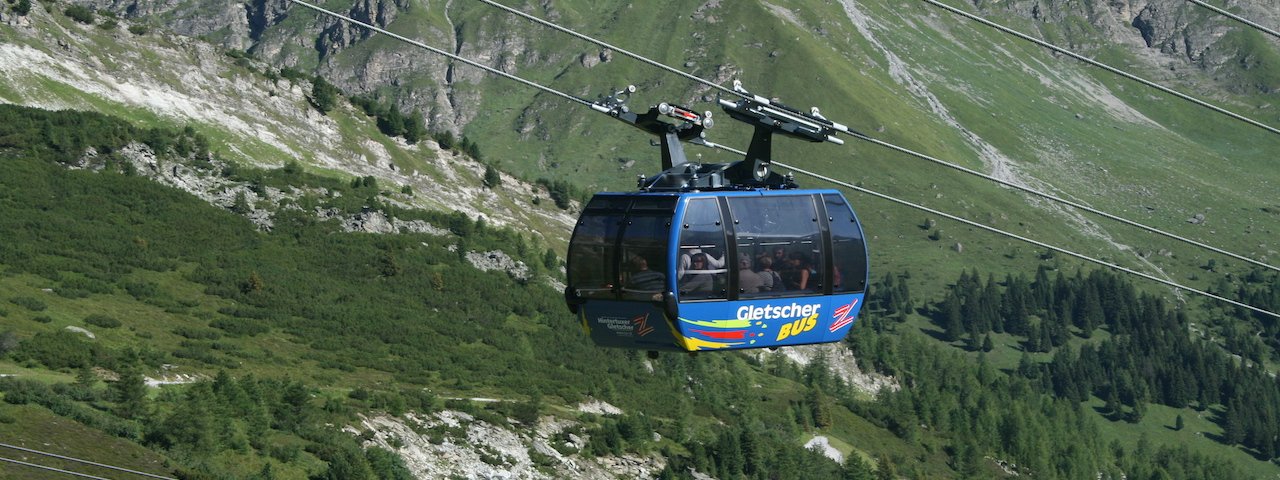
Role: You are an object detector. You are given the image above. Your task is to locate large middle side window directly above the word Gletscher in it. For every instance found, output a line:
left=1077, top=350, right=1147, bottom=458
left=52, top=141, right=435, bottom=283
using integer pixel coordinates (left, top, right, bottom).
left=728, top=195, right=823, bottom=298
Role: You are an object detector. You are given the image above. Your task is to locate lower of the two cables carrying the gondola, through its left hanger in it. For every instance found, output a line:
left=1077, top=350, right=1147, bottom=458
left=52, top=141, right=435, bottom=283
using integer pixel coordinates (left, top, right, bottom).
left=289, top=0, right=1280, bottom=323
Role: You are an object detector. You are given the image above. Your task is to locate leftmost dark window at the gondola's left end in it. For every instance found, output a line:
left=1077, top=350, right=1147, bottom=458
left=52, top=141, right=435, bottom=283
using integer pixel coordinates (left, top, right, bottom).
left=568, top=212, right=622, bottom=298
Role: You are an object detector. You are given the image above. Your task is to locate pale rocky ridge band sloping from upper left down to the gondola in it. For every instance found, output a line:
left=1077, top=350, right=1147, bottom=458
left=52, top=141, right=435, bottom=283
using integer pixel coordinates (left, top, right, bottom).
left=0, top=5, right=573, bottom=244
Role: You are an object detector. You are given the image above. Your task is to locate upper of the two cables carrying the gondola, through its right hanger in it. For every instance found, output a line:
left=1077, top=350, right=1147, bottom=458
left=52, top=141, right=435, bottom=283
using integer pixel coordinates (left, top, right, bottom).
left=479, top=0, right=1280, bottom=271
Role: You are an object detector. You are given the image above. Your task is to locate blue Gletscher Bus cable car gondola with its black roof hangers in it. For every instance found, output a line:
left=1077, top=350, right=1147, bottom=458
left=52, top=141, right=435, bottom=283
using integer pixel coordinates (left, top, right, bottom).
left=564, top=84, right=868, bottom=352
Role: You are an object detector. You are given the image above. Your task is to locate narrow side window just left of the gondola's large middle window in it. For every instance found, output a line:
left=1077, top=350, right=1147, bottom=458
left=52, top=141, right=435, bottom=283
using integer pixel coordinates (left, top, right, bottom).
left=676, top=198, right=727, bottom=301
